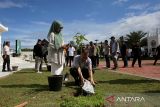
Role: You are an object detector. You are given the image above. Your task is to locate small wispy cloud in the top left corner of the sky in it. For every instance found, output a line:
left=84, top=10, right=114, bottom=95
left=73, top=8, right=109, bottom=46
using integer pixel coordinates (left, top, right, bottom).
left=0, top=1, right=24, bottom=8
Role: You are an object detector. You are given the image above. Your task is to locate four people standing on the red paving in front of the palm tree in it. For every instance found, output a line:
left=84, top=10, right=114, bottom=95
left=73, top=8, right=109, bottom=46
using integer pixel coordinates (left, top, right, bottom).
left=104, top=36, right=142, bottom=69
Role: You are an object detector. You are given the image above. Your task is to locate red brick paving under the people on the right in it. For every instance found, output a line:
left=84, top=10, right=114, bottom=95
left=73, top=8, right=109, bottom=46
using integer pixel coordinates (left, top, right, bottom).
left=99, top=60, right=160, bottom=80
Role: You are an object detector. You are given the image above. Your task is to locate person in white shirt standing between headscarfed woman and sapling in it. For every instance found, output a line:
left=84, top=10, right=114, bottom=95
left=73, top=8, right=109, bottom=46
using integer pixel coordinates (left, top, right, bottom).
left=68, top=44, right=75, bottom=67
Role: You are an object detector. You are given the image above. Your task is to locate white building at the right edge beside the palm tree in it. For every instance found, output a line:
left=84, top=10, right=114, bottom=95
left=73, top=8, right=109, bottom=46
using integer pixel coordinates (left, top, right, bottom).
left=147, top=28, right=160, bottom=56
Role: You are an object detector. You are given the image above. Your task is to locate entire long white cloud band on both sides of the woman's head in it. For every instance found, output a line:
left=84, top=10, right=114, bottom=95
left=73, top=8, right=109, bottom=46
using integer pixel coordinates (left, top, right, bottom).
left=3, top=11, right=160, bottom=47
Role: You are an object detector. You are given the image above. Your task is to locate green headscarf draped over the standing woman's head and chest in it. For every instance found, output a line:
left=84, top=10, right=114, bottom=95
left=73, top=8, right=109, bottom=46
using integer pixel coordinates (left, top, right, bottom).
left=48, top=21, right=63, bottom=49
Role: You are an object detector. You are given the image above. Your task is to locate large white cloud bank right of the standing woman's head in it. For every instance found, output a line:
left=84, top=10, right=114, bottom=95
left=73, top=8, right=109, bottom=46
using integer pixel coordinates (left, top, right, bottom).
left=64, top=12, right=160, bottom=41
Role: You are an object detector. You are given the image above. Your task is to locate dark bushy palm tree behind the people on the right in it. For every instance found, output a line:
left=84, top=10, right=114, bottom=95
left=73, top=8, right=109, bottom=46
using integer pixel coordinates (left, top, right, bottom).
left=126, top=31, right=147, bottom=48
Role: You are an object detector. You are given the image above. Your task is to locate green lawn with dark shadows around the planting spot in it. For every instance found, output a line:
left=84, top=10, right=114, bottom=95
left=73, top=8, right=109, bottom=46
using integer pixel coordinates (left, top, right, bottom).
left=0, top=68, right=160, bottom=107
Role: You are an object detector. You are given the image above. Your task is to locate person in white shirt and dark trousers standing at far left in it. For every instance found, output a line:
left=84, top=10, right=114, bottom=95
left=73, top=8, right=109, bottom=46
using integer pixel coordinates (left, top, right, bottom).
left=2, top=41, right=11, bottom=72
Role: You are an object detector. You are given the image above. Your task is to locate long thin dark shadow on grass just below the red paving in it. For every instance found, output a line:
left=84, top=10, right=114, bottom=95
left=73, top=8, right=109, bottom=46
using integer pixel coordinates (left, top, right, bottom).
left=98, top=79, right=160, bottom=85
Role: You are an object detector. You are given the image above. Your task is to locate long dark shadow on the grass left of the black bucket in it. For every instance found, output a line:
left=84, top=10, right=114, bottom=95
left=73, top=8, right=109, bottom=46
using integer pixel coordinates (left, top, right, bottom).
left=0, top=84, right=49, bottom=91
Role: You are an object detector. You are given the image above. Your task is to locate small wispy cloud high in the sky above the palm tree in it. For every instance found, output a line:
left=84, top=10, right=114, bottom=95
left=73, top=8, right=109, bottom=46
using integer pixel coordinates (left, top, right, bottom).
left=129, top=3, right=149, bottom=10
